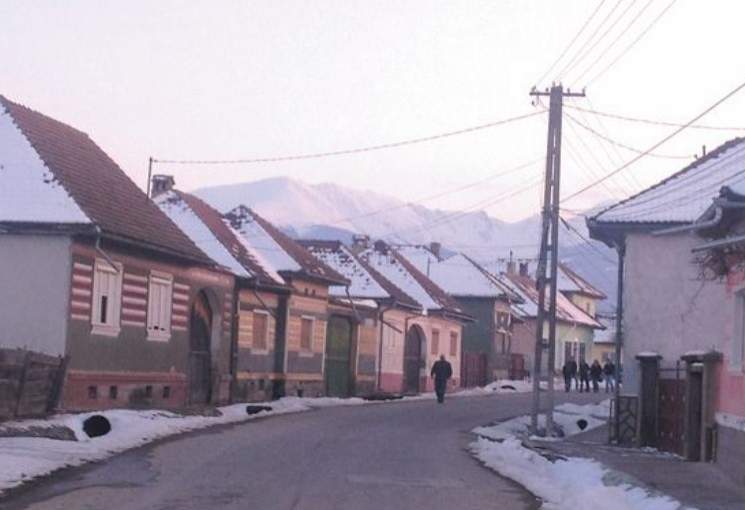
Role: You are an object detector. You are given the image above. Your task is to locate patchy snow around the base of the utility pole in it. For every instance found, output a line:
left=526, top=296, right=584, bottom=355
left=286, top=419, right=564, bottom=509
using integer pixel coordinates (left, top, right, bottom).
left=473, top=400, right=610, bottom=440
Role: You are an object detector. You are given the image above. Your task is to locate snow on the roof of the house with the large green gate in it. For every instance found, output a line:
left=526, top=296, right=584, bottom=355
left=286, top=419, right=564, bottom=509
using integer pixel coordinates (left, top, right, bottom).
left=301, top=241, right=391, bottom=299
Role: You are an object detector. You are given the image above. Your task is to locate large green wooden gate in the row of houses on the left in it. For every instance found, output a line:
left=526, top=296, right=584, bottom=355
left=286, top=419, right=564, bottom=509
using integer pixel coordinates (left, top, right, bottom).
left=326, top=317, right=352, bottom=397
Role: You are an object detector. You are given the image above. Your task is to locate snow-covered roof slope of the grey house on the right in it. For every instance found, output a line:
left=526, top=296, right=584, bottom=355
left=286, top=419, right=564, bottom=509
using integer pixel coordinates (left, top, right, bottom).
left=592, top=138, right=745, bottom=223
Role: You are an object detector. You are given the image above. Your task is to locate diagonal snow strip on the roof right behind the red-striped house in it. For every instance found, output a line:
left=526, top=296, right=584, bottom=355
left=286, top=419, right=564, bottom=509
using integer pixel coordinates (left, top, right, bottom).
left=155, top=191, right=253, bottom=278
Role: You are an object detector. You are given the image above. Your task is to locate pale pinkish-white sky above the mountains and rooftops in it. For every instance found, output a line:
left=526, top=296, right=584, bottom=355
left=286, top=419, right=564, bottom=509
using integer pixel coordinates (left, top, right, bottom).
left=0, top=0, right=745, bottom=221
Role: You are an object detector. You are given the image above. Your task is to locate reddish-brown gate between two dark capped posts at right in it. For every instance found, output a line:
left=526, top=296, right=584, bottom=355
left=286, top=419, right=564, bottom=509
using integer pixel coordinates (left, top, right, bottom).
left=657, top=361, right=686, bottom=455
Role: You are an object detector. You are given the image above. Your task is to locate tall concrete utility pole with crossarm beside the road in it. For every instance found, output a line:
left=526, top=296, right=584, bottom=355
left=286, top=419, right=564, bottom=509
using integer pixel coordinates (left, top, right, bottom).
left=530, top=84, right=585, bottom=436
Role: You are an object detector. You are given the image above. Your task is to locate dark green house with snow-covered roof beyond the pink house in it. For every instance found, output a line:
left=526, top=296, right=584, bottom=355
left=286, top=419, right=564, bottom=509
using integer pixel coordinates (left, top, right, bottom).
left=396, top=243, right=525, bottom=387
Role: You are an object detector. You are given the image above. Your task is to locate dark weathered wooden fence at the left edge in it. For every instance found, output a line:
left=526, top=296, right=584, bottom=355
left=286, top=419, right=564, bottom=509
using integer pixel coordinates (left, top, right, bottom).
left=0, top=349, right=68, bottom=420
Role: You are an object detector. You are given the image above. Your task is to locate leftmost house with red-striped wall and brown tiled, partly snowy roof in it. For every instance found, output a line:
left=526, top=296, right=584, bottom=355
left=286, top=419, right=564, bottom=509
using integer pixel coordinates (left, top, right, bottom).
left=0, top=96, right=233, bottom=410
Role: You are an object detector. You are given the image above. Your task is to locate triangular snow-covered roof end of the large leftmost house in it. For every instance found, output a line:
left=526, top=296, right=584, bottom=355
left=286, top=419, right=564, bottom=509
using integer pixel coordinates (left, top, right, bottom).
left=0, top=102, right=92, bottom=224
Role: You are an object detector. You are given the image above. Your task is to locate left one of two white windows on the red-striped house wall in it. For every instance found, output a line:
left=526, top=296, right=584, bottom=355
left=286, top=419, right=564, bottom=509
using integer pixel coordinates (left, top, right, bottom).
left=91, top=259, right=122, bottom=336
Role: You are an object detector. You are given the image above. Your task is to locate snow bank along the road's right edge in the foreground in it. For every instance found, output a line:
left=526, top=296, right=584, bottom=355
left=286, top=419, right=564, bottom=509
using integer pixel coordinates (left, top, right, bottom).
left=471, top=437, right=683, bottom=510
